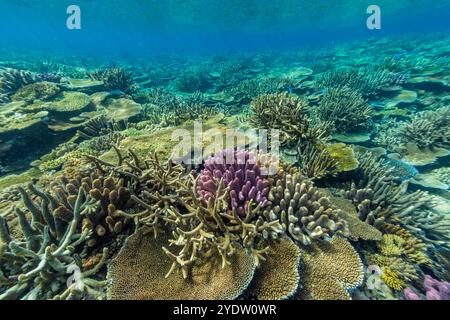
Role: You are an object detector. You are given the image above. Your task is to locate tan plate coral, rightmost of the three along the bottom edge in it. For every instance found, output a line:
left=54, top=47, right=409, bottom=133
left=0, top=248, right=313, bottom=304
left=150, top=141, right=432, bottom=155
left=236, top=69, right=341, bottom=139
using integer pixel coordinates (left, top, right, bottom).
left=297, top=237, right=364, bottom=300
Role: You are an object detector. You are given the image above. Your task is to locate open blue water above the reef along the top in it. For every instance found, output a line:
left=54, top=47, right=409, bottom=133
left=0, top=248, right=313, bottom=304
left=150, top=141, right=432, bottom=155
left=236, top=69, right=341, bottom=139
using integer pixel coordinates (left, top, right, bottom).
left=0, top=0, right=450, bottom=56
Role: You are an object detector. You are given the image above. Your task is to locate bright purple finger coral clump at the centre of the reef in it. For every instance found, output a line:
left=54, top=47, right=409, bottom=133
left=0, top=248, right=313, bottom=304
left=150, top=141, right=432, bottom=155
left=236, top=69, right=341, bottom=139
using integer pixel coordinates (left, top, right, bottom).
left=196, top=149, right=269, bottom=215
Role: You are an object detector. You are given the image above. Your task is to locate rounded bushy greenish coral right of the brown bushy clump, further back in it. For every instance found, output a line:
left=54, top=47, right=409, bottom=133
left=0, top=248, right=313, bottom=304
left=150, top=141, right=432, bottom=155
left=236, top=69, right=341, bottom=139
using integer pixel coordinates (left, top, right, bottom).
left=313, top=87, right=373, bottom=133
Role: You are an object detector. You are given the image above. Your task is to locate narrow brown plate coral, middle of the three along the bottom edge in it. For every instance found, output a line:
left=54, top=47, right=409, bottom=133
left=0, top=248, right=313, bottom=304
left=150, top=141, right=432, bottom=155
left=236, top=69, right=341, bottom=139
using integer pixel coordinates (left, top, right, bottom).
left=248, top=237, right=300, bottom=300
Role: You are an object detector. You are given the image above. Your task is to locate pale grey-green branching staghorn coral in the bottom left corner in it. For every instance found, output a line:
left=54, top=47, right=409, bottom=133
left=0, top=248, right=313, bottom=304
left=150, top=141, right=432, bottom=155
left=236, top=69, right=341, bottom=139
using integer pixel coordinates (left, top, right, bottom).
left=0, top=184, right=107, bottom=300
